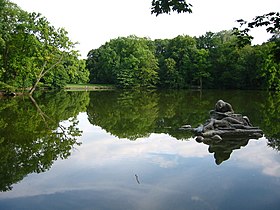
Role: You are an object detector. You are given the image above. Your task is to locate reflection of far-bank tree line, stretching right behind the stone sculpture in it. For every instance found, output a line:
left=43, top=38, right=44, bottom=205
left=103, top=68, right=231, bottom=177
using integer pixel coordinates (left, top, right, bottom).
left=87, top=88, right=280, bottom=149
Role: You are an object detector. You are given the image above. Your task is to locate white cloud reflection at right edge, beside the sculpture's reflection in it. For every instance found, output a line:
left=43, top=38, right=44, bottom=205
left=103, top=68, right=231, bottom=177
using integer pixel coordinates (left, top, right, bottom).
left=235, top=137, right=280, bottom=177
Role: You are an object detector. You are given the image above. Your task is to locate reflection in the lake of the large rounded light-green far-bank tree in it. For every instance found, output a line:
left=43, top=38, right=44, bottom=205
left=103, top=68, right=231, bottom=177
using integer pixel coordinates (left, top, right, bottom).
left=88, top=91, right=158, bottom=140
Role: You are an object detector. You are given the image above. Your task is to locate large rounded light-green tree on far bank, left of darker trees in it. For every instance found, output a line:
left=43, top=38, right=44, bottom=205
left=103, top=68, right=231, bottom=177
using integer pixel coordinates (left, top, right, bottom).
left=87, top=36, right=158, bottom=88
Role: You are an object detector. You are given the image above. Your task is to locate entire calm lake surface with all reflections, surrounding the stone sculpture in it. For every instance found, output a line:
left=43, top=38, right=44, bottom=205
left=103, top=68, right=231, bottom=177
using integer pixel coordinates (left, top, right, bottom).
left=0, top=91, right=280, bottom=210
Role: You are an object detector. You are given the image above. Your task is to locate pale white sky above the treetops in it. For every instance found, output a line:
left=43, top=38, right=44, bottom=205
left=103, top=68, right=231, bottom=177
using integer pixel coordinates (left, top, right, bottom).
left=11, top=0, right=280, bottom=58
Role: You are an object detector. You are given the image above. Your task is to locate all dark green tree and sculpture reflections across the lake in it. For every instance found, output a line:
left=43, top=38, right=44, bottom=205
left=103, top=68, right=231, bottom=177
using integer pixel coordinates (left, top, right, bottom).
left=0, top=90, right=280, bottom=191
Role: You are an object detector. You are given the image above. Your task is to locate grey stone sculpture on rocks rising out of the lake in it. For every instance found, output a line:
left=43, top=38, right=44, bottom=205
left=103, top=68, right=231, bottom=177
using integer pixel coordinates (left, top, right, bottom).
left=182, top=100, right=263, bottom=142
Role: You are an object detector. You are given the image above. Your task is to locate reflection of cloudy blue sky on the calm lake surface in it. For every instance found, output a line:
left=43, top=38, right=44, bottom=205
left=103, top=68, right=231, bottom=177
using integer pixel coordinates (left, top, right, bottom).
left=0, top=113, right=280, bottom=210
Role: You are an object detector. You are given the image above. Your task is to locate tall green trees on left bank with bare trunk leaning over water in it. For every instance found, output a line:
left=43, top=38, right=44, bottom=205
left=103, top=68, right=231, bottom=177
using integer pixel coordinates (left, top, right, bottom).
left=0, top=0, right=89, bottom=93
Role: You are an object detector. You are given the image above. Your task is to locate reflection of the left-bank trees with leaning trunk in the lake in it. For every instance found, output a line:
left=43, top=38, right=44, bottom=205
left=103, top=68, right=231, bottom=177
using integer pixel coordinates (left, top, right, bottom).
left=0, top=92, right=88, bottom=191
